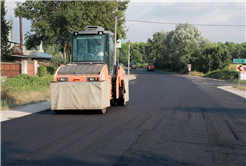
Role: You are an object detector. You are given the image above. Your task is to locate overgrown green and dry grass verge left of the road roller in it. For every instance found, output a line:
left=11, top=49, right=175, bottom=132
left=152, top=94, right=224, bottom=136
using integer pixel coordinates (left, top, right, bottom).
left=0, top=74, right=53, bottom=110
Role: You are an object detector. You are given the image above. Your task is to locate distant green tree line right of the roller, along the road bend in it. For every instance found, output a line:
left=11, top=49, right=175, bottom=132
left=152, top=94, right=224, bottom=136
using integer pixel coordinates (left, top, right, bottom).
left=119, top=23, right=246, bottom=73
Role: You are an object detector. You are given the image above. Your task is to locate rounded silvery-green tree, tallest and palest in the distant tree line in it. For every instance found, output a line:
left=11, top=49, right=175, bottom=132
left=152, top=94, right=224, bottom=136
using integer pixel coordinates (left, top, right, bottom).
left=162, top=23, right=214, bottom=70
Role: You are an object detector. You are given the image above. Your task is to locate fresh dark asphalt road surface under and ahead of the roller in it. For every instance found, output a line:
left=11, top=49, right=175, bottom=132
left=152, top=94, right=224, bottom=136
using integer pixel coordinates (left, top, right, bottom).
left=0, top=69, right=246, bottom=166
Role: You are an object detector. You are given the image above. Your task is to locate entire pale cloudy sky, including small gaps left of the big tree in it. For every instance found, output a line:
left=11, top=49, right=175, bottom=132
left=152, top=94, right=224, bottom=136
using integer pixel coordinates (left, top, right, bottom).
left=5, top=0, right=246, bottom=43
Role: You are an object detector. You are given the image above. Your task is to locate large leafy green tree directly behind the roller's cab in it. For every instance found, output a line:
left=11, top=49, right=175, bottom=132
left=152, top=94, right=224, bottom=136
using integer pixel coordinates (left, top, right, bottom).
left=15, top=0, right=130, bottom=61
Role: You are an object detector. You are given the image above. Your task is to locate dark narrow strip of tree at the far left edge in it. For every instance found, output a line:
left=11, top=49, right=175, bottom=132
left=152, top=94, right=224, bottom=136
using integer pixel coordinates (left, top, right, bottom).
left=0, top=0, right=11, bottom=60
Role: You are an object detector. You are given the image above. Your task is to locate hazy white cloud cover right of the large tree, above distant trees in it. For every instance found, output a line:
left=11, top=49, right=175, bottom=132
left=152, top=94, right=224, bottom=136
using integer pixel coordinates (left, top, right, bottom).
left=126, top=1, right=245, bottom=43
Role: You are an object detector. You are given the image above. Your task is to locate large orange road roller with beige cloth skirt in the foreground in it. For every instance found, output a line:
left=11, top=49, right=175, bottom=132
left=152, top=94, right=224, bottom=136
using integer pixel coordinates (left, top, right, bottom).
left=50, top=26, right=129, bottom=113
